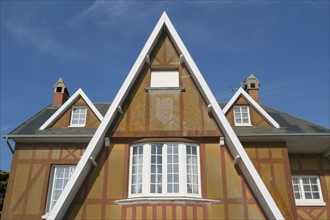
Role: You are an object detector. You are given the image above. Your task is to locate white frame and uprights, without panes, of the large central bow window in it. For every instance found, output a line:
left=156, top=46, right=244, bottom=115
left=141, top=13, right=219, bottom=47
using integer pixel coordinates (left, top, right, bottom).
left=128, top=142, right=202, bottom=199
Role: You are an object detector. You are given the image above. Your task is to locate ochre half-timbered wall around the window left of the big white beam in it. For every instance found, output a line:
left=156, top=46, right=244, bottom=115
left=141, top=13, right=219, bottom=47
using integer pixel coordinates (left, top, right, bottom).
left=1, top=144, right=86, bottom=220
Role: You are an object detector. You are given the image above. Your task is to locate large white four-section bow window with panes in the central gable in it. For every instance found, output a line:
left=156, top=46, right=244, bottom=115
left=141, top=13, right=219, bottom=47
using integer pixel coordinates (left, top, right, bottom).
left=129, top=143, right=201, bottom=198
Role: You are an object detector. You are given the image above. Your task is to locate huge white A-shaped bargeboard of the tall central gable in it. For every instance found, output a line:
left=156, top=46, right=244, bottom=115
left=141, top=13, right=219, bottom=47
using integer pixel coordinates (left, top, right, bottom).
left=47, top=12, right=283, bottom=219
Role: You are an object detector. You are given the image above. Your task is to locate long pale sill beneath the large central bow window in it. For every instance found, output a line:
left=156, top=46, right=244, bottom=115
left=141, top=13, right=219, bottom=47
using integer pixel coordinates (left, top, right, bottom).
left=115, top=197, right=221, bottom=205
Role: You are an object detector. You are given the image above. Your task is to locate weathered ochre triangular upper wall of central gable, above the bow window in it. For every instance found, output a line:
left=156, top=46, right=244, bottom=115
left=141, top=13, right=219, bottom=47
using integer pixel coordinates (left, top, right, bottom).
left=108, top=31, right=222, bottom=137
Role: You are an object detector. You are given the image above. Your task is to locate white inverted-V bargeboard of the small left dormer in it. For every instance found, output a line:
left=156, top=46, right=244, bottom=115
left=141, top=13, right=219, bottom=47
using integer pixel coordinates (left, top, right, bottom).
left=40, top=88, right=103, bottom=130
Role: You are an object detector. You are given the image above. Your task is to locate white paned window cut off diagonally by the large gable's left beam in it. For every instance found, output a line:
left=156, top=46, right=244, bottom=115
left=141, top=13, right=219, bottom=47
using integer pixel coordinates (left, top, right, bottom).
left=46, top=165, right=76, bottom=212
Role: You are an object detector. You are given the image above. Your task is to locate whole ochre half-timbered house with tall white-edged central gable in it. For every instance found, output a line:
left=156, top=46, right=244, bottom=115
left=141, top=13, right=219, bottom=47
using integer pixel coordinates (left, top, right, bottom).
left=3, top=12, right=330, bottom=219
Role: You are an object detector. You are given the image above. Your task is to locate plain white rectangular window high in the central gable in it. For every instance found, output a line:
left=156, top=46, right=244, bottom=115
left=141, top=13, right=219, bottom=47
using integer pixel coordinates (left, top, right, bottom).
left=150, top=71, right=179, bottom=88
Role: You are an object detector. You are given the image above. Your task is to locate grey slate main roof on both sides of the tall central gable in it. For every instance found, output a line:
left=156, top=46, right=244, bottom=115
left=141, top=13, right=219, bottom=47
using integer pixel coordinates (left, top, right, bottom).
left=8, top=103, right=330, bottom=137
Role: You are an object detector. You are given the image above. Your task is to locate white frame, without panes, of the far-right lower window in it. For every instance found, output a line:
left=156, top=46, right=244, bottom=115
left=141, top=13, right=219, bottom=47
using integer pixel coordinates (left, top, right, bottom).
left=291, top=175, right=326, bottom=206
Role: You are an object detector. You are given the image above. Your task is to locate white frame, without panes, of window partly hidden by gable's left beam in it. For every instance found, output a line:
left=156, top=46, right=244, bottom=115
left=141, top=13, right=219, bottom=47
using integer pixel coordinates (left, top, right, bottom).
left=46, top=164, right=76, bottom=213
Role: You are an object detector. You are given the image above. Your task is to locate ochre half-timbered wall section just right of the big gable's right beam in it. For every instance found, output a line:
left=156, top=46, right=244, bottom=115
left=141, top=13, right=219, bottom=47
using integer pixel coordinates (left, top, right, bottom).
left=242, top=142, right=297, bottom=219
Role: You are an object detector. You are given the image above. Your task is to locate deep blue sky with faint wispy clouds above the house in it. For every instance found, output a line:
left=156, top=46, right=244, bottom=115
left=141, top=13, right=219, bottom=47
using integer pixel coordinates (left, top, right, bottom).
left=0, top=0, right=330, bottom=171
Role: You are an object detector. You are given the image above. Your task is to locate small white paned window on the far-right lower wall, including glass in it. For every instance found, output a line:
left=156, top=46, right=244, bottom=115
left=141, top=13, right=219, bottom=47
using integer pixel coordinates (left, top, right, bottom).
left=292, top=176, right=325, bottom=206
